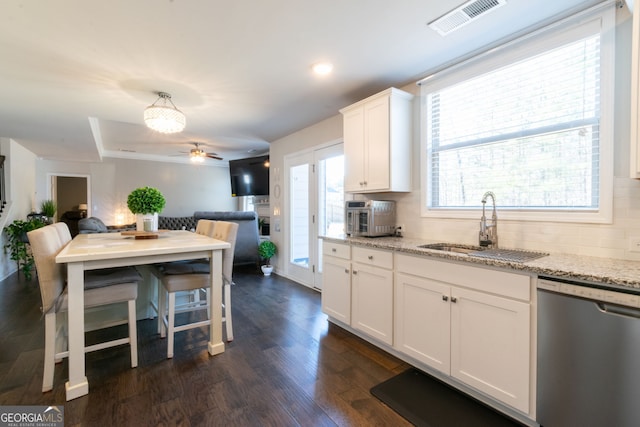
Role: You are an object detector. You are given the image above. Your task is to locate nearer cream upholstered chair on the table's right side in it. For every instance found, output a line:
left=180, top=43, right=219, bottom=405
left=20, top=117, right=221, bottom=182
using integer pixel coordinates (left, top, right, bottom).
left=154, top=220, right=238, bottom=358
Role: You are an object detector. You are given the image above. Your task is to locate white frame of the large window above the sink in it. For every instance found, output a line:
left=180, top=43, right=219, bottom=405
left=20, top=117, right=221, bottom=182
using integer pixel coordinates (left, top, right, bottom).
left=418, top=5, right=615, bottom=224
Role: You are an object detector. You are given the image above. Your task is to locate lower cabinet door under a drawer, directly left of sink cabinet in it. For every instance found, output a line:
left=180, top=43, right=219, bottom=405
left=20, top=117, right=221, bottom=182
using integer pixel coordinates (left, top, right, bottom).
left=351, top=263, right=393, bottom=345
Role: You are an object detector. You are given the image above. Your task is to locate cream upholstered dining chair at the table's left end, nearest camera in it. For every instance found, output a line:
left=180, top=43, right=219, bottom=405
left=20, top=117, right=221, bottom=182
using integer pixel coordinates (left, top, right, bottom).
left=27, top=223, right=142, bottom=392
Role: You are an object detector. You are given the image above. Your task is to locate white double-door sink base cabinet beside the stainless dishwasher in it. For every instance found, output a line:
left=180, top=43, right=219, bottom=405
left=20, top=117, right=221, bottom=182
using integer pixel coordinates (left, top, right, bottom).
left=394, top=255, right=531, bottom=413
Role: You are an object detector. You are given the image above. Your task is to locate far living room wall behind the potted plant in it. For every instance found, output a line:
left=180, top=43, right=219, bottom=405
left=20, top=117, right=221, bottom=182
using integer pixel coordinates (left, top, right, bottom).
left=35, top=158, right=236, bottom=224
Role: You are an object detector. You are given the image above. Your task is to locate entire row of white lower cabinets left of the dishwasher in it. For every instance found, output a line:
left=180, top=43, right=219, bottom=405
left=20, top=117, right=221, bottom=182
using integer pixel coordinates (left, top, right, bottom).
left=322, top=242, right=534, bottom=414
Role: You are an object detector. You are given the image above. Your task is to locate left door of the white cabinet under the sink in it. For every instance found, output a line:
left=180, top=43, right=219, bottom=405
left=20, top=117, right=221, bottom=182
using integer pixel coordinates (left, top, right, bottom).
left=394, top=273, right=451, bottom=375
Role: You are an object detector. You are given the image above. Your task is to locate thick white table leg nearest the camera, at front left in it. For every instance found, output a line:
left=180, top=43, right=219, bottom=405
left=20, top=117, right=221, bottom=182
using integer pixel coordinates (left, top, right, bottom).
left=65, top=262, right=89, bottom=400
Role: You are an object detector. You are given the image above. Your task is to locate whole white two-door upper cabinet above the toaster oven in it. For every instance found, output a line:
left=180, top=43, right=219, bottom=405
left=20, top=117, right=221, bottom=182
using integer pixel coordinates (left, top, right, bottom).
left=340, top=88, right=413, bottom=193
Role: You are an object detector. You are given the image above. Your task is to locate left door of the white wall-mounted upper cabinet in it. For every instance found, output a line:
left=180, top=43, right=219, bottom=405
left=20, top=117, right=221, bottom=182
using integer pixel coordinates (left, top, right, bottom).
left=343, top=107, right=365, bottom=192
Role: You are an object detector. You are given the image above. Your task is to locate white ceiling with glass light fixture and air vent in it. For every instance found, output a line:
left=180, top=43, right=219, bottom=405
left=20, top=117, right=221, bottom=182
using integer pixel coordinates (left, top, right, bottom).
left=0, top=0, right=601, bottom=164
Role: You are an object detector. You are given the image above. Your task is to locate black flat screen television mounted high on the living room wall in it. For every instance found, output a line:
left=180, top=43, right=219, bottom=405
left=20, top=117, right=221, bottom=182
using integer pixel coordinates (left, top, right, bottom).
left=229, top=155, right=269, bottom=197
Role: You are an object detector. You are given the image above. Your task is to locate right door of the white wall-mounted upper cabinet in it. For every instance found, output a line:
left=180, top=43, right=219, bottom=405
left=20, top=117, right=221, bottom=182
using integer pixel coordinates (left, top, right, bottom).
left=364, top=96, right=391, bottom=191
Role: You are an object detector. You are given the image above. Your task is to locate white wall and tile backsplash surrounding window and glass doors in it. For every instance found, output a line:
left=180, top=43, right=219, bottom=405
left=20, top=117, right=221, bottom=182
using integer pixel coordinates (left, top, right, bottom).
left=271, top=8, right=640, bottom=260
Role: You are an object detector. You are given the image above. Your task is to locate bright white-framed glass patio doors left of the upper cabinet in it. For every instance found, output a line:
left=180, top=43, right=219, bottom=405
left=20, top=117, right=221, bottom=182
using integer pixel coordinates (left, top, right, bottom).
left=285, top=143, right=344, bottom=289
